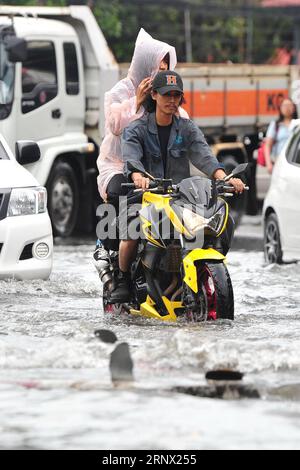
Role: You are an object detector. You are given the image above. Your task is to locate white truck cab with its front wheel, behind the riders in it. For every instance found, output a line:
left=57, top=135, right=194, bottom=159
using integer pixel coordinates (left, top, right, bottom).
left=0, top=6, right=119, bottom=236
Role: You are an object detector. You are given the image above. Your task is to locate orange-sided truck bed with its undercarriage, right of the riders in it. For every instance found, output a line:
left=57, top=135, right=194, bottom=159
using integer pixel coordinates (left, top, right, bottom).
left=176, top=64, right=300, bottom=214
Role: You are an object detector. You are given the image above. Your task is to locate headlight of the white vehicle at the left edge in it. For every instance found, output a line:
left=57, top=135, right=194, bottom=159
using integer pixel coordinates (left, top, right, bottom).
left=7, top=187, right=47, bottom=217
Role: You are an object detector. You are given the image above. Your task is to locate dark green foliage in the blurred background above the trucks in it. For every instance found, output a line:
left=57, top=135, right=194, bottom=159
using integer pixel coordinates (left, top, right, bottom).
left=5, top=0, right=300, bottom=63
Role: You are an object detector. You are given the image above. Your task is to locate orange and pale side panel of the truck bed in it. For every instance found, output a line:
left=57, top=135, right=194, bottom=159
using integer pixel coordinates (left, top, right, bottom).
left=177, top=64, right=300, bottom=132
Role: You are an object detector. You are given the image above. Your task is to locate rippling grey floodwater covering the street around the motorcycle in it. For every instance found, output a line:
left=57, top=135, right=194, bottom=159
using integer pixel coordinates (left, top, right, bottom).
left=0, top=245, right=300, bottom=450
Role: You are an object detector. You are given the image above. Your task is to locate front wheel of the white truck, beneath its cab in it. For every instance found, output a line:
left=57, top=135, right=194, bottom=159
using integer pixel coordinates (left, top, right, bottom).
left=46, top=162, right=79, bottom=237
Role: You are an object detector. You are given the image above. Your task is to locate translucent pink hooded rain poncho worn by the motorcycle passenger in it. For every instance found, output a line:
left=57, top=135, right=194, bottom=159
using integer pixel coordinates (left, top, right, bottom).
left=97, top=29, right=184, bottom=200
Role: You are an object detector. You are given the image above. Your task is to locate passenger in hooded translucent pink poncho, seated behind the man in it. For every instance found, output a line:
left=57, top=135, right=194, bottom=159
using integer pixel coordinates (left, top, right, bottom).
left=94, top=29, right=188, bottom=268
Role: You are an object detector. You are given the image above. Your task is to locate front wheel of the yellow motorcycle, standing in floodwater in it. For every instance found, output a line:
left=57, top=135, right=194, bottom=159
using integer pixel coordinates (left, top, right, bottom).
left=198, top=263, right=234, bottom=320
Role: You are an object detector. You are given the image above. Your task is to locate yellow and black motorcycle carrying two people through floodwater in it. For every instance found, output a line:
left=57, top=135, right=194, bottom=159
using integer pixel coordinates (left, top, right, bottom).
left=100, top=164, right=248, bottom=322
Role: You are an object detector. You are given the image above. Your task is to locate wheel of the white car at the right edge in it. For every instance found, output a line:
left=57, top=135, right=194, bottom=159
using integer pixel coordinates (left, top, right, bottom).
left=264, top=214, right=283, bottom=264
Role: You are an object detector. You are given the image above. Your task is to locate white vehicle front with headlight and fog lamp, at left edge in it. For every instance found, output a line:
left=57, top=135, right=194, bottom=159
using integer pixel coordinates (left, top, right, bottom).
left=0, top=134, right=53, bottom=280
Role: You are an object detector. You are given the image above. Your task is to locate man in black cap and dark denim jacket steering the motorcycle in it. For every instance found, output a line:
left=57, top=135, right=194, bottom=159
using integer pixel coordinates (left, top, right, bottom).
left=111, top=71, right=245, bottom=303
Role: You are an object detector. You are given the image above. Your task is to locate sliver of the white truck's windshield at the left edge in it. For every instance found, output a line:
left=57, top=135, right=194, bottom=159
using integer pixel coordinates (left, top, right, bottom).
left=0, top=37, right=15, bottom=120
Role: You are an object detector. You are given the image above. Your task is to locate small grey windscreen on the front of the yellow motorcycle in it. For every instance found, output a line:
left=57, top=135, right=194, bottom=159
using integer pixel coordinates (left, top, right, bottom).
left=178, top=176, right=217, bottom=209
